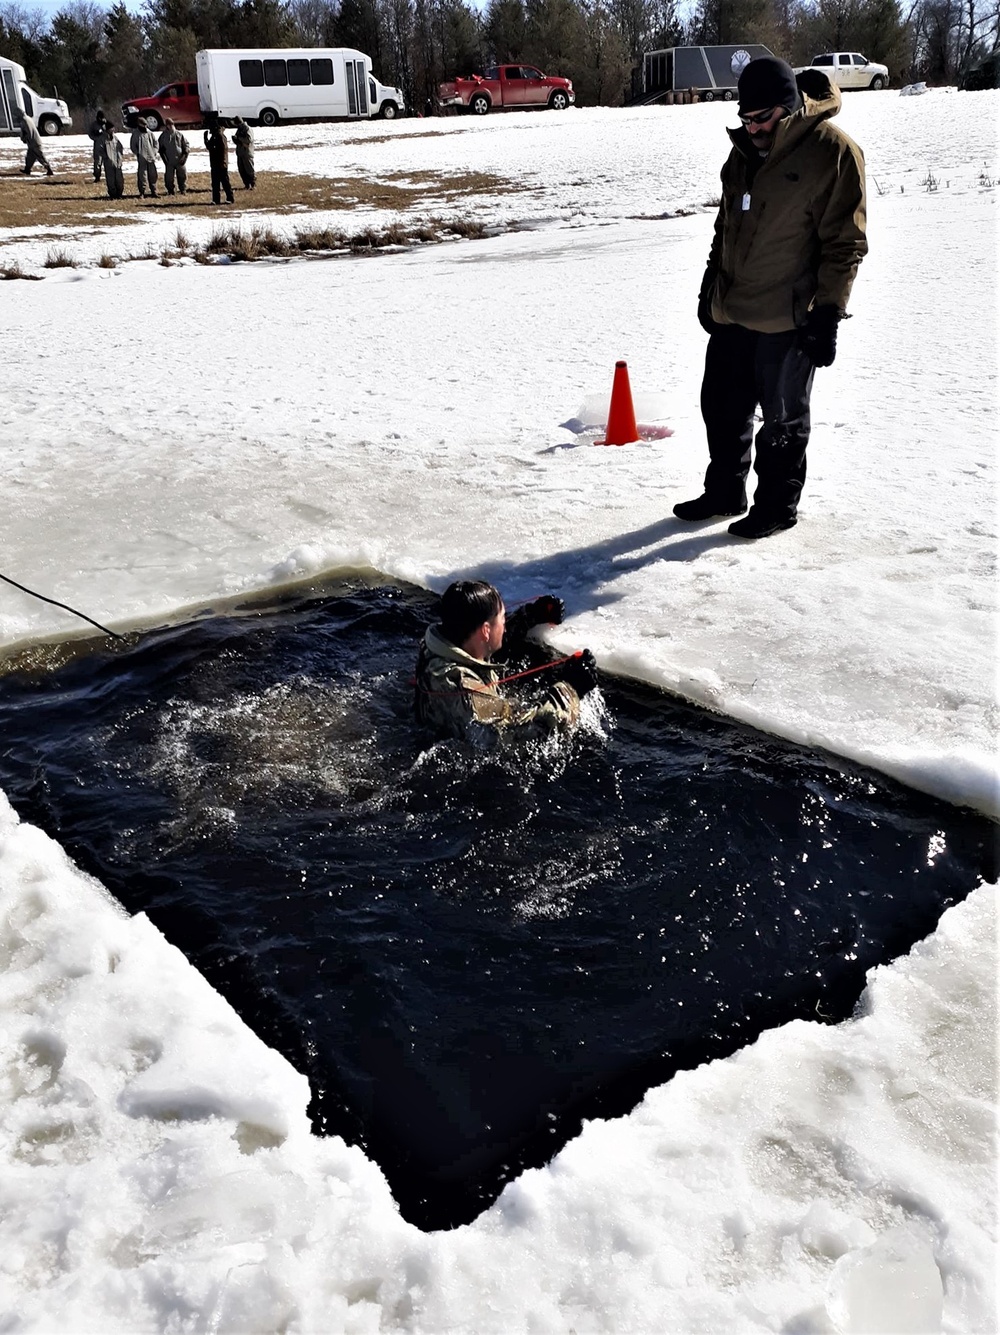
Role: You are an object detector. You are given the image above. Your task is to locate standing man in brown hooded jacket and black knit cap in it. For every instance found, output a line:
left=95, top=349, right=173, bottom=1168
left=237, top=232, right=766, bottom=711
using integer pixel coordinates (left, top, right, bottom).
left=674, top=56, right=868, bottom=538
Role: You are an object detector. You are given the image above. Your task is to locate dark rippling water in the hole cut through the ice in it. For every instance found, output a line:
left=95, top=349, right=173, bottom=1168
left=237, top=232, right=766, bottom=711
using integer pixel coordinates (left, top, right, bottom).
left=0, top=585, right=996, bottom=1227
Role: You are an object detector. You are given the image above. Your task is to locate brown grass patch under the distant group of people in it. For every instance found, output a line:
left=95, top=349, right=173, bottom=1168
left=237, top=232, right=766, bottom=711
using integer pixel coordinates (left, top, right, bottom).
left=0, top=162, right=525, bottom=240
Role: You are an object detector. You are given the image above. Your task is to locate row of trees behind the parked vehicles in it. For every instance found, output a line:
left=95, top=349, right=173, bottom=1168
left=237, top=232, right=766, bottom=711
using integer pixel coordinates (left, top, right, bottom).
left=0, top=0, right=1000, bottom=124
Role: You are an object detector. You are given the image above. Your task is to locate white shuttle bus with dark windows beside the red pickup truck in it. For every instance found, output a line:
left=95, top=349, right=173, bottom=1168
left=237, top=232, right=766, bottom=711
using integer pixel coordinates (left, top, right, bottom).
left=195, top=47, right=403, bottom=125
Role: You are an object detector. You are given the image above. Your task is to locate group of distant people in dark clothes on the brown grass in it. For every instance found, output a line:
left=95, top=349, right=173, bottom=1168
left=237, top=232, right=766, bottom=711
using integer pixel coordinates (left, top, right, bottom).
left=80, top=111, right=256, bottom=204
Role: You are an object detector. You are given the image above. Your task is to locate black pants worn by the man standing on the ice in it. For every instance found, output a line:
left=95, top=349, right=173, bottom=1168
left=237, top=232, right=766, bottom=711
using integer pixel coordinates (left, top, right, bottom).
left=701, top=324, right=816, bottom=519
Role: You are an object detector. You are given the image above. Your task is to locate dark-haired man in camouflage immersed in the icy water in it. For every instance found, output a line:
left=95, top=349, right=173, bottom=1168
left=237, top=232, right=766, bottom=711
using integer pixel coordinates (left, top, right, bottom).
left=414, top=579, right=597, bottom=738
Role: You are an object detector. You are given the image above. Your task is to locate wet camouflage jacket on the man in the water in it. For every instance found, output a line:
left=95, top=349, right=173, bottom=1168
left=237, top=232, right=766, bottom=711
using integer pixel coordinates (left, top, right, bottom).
left=414, top=626, right=579, bottom=740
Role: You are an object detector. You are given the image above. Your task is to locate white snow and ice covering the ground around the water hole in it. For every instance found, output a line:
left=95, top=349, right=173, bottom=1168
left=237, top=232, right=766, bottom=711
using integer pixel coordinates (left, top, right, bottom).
left=0, top=91, right=1000, bottom=1335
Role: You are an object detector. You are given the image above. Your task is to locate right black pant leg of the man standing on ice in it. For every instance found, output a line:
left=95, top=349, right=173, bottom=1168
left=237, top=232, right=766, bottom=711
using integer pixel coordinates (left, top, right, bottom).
left=753, top=330, right=816, bottom=519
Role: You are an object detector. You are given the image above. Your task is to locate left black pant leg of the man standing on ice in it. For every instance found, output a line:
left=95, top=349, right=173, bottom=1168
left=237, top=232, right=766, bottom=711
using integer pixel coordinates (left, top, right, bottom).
left=701, top=324, right=760, bottom=510
